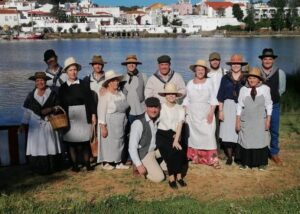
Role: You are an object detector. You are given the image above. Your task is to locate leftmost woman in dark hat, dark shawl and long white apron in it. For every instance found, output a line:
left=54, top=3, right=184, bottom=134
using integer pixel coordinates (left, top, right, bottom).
left=21, top=72, right=61, bottom=174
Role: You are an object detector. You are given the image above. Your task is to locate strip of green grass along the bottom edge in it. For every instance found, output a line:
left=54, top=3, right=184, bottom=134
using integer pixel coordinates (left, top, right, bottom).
left=0, top=188, right=300, bottom=214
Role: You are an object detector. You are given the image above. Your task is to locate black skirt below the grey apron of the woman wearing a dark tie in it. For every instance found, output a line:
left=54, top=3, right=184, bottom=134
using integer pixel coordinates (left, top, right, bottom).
left=238, top=145, right=269, bottom=168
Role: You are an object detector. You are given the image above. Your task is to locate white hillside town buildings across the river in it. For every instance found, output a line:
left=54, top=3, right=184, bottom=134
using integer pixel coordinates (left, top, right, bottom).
left=0, top=0, right=300, bottom=36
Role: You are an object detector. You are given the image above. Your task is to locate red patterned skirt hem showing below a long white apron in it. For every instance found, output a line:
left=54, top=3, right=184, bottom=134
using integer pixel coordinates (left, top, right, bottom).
left=187, top=147, right=219, bottom=166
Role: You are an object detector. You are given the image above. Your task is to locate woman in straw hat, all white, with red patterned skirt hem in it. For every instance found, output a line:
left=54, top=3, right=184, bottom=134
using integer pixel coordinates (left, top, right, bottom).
left=183, top=60, right=220, bottom=169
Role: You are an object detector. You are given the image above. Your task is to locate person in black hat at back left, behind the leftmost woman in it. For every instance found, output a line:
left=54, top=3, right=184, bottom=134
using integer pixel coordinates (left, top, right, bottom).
left=44, top=49, right=67, bottom=92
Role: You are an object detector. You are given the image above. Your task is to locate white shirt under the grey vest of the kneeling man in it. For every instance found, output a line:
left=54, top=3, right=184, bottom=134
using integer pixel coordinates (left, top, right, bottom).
left=128, top=113, right=159, bottom=166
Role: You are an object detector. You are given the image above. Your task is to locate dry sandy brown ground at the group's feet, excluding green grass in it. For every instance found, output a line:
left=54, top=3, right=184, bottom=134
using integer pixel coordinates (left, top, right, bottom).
left=0, top=136, right=300, bottom=202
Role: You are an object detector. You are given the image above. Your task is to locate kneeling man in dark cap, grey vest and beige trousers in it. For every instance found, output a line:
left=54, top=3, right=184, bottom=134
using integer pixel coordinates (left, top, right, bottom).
left=129, top=97, right=165, bottom=182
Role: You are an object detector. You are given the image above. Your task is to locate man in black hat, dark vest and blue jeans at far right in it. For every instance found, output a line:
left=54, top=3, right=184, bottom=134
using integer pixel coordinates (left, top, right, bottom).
left=259, top=48, right=286, bottom=165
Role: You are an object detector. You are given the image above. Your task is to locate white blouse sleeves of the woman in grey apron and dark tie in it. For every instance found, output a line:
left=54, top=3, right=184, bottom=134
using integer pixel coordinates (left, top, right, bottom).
left=236, top=84, right=273, bottom=116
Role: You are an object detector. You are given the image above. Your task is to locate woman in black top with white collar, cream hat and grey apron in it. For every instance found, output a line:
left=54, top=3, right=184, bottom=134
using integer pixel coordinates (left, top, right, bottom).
left=59, top=57, right=97, bottom=172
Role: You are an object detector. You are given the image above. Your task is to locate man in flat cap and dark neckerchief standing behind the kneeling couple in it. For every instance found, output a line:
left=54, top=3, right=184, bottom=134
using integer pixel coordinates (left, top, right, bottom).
left=145, top=55, right=185, bottom=102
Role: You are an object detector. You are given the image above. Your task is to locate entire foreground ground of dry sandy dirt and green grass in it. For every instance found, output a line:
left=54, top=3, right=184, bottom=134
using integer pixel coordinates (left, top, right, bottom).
left=0, top=112, right=300, bottom=214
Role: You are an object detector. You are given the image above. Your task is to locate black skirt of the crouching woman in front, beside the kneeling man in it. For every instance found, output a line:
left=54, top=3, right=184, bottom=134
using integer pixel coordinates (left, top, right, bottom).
left=156, top=129, right=185, bottom=175
